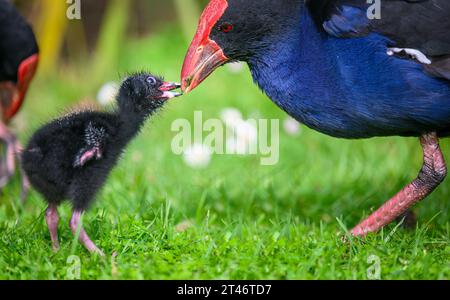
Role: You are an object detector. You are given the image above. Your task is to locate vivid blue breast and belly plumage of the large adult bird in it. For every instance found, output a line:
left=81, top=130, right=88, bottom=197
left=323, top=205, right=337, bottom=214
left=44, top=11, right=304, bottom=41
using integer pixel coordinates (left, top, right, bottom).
left=249, top=10, right=450, bottom=138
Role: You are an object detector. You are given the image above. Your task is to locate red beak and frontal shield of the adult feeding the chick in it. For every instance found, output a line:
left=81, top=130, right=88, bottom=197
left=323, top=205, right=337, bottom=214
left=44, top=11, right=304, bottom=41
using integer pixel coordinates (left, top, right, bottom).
left=181, top=0, right=229, bottom=93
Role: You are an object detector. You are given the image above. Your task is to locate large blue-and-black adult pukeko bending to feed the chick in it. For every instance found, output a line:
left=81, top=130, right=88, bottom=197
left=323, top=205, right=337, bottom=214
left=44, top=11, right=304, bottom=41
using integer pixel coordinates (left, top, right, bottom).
left=182, top=0, right=450, bottom=236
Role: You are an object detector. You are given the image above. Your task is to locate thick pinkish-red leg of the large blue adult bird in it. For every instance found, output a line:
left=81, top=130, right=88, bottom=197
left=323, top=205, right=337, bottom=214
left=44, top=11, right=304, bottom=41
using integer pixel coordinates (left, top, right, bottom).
left=351, top=133, right=447, bottom=236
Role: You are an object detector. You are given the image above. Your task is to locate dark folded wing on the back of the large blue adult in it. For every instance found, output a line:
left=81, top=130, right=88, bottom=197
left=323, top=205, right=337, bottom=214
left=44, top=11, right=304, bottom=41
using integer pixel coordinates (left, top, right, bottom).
left=309, top=0, right=450, bottom=80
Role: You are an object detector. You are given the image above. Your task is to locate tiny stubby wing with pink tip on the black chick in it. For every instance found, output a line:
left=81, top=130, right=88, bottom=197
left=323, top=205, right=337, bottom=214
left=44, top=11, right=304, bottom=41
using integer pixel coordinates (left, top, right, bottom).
left=73, top=122, right=106, bottom=168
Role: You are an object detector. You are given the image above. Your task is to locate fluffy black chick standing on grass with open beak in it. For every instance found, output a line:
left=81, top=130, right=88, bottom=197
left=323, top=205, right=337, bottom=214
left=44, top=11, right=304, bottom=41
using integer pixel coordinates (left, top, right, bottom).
left=22, top=73, right=181, bottom=254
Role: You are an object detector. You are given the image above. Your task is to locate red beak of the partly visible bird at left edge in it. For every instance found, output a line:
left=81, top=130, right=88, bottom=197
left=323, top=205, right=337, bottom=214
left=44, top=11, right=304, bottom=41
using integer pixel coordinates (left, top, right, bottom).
left=3, top=54, right=39, bottom=121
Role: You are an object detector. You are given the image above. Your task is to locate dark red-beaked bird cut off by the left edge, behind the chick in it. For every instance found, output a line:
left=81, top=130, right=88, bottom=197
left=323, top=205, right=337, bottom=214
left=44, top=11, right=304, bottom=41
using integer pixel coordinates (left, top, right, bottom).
left=0, top=0, right=39, bottom=198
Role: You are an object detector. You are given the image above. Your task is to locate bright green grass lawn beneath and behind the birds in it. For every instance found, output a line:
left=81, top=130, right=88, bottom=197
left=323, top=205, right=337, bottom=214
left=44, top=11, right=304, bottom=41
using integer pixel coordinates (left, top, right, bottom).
left=0, top=27, right=450, bottom=279
